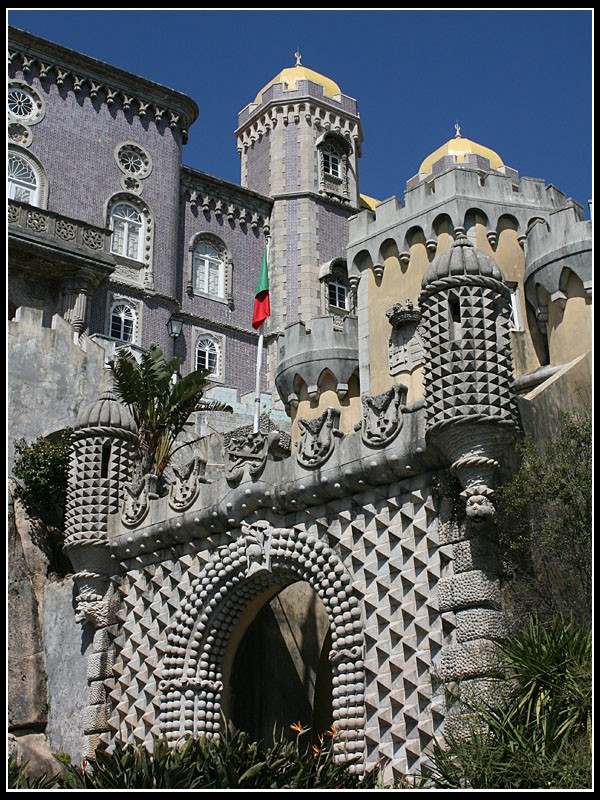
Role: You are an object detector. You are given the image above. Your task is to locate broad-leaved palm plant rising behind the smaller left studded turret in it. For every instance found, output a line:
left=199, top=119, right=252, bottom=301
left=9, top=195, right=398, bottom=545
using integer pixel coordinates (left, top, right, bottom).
left=110, top=344, right=232, bottom=478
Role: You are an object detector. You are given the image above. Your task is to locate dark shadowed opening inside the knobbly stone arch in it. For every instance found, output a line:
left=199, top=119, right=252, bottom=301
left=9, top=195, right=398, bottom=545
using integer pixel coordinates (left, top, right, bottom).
left=222, top=581, right=333, bottom=743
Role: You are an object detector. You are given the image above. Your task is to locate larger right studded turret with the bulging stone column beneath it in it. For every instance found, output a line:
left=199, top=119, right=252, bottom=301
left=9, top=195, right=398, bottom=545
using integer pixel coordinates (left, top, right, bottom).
left=420, top=229, right=517, bottom=724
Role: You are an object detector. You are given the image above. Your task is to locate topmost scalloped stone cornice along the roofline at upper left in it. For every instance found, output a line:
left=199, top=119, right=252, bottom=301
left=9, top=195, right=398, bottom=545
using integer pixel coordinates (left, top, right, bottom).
left=8, top=27, right=198, bottom=144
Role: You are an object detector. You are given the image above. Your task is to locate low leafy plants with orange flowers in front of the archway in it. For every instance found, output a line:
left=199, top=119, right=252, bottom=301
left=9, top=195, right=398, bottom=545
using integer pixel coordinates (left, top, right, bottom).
left=9, top=726, right=378, bottom=790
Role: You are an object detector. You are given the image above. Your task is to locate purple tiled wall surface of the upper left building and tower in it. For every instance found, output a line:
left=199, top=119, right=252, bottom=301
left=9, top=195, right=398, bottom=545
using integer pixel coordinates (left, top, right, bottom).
left=9, top=29, right=357, bottom=398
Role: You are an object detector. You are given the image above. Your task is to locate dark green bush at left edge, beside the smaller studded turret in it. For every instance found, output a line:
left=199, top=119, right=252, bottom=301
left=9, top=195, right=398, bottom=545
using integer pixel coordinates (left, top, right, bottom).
left=13, top=428, right=73, bottom=530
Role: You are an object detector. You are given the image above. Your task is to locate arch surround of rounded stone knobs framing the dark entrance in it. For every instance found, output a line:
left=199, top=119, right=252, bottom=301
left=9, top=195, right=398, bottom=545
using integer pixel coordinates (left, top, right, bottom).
left=159, top=522, right=365, bottom=771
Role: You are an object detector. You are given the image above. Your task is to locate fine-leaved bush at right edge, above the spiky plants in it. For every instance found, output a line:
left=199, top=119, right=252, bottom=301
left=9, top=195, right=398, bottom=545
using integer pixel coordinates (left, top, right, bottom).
left=500, top=414, right=592, bottom=624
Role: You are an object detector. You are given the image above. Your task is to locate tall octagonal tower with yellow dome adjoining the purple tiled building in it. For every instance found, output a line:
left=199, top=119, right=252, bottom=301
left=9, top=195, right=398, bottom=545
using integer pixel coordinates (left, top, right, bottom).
left=236, top=54, right=362, bottom=338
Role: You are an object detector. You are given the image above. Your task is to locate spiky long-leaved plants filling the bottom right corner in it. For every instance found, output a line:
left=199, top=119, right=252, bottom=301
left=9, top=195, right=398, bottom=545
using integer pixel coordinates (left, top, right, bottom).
left=421, top=617, right=592, bottom=789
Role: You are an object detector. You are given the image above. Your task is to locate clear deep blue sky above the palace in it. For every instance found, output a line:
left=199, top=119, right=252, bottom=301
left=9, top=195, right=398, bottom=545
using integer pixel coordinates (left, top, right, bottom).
left=7, top=9, right=593, bottom=216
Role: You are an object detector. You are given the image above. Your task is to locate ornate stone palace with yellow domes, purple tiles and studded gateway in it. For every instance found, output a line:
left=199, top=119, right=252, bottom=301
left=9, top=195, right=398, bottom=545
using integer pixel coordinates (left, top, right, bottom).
left=8, top=28, right=592, bottom=779
